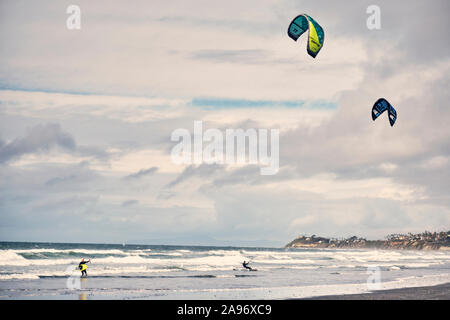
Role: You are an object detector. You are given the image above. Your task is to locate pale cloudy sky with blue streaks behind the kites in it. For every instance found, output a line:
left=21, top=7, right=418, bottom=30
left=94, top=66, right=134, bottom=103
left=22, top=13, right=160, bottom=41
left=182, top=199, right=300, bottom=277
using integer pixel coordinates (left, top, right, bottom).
left=0, top=0, right=450, bottom=246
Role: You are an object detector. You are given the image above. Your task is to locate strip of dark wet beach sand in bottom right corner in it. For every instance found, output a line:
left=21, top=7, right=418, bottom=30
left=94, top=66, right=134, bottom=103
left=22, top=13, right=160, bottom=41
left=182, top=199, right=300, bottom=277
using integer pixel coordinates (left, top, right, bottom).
left=307, top=282, right=450, bottom=300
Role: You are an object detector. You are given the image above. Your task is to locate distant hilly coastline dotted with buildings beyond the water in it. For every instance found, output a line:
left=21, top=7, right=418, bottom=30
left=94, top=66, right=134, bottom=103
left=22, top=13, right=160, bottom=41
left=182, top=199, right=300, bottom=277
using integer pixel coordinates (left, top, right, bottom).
left=285, top=231, right=450, bottom=250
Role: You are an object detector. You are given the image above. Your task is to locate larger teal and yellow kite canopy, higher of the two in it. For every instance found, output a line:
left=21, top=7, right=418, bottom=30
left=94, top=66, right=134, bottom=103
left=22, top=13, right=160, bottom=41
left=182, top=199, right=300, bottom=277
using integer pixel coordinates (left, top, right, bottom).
left=288, top=14, right=325, bottom=58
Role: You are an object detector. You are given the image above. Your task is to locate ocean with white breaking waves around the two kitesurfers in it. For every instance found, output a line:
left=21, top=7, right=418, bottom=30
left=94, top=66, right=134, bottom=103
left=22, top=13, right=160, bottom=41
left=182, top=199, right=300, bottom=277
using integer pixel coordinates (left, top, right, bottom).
left=0, top=242, right=450, bottom=300
